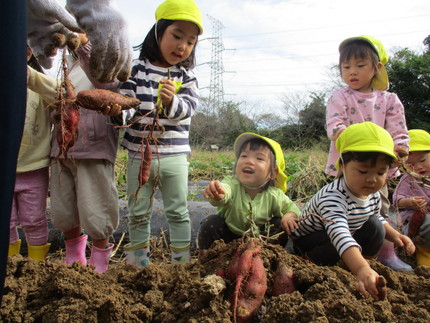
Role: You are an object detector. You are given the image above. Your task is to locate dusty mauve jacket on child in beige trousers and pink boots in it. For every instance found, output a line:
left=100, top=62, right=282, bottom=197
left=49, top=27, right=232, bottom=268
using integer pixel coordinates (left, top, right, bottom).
left=51, top=42, right=120, bottom=164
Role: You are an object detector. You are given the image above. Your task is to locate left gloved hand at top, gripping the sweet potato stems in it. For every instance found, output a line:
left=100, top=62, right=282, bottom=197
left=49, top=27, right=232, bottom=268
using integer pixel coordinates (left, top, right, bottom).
left=27, top=0, right=82, bottom=68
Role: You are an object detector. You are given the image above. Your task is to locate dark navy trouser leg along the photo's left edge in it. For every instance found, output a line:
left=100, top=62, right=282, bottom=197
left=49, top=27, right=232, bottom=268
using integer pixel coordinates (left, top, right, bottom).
left=0, top=0, right=27, bottom=304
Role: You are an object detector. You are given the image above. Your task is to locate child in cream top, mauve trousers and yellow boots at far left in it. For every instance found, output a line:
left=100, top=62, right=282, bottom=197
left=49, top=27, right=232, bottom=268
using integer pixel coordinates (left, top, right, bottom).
left=8, top=47, right=58, bottom=261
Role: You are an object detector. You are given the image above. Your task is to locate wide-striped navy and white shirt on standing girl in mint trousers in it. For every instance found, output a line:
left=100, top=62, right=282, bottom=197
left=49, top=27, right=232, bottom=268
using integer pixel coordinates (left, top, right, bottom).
left=120, top=59, right=199, bottom=158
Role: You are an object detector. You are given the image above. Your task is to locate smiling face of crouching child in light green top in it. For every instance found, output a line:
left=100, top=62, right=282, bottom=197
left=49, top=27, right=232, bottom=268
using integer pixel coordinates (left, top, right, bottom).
left=236, top=144, right=272, bottom=192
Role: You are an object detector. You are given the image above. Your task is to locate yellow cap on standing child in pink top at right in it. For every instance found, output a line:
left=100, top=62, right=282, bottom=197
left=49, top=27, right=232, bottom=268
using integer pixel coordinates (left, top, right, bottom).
left=339, top=35, right=390, bottom=91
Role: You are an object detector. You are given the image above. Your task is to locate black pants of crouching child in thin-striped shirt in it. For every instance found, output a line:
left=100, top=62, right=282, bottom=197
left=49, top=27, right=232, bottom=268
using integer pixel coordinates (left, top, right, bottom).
left=294, top=216, right=385, bottom=266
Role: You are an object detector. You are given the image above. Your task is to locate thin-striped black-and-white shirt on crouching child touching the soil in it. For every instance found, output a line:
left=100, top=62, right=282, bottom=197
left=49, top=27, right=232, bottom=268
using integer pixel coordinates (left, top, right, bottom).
left=293, top=177, right=387, bottom=256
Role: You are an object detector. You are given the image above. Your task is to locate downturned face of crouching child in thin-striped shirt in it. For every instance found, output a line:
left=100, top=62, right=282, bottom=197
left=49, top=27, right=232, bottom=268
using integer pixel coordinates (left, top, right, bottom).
left=342, top=155, right=390, bottom=199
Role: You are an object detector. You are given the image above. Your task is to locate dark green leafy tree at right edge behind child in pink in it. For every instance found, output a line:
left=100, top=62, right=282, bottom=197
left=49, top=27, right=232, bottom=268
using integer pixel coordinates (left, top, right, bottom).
left=387, top=46, right=430, bottom=131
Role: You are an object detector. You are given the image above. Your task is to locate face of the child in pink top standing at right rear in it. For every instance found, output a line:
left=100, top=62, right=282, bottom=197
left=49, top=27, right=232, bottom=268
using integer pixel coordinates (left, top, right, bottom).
left=340, top=57, right=381, bottom=93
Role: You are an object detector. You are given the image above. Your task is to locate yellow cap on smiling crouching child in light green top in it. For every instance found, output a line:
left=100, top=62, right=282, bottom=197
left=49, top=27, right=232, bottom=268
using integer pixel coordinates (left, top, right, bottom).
left=234, top=132, right=287, bottom=193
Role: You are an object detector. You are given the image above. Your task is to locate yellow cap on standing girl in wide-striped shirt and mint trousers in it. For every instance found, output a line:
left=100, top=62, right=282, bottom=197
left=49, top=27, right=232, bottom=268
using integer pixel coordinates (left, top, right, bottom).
left=155, top=0, right=203, bottom=35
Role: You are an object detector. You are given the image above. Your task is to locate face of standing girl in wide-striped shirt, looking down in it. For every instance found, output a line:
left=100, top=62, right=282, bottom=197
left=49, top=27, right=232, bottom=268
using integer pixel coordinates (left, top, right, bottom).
left=159, top=20, right=199, bottom=67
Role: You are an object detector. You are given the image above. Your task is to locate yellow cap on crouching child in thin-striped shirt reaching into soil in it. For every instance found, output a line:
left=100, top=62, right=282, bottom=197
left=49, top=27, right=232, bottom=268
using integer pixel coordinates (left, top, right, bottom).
left=336, top=122, right=397, bottom=169
